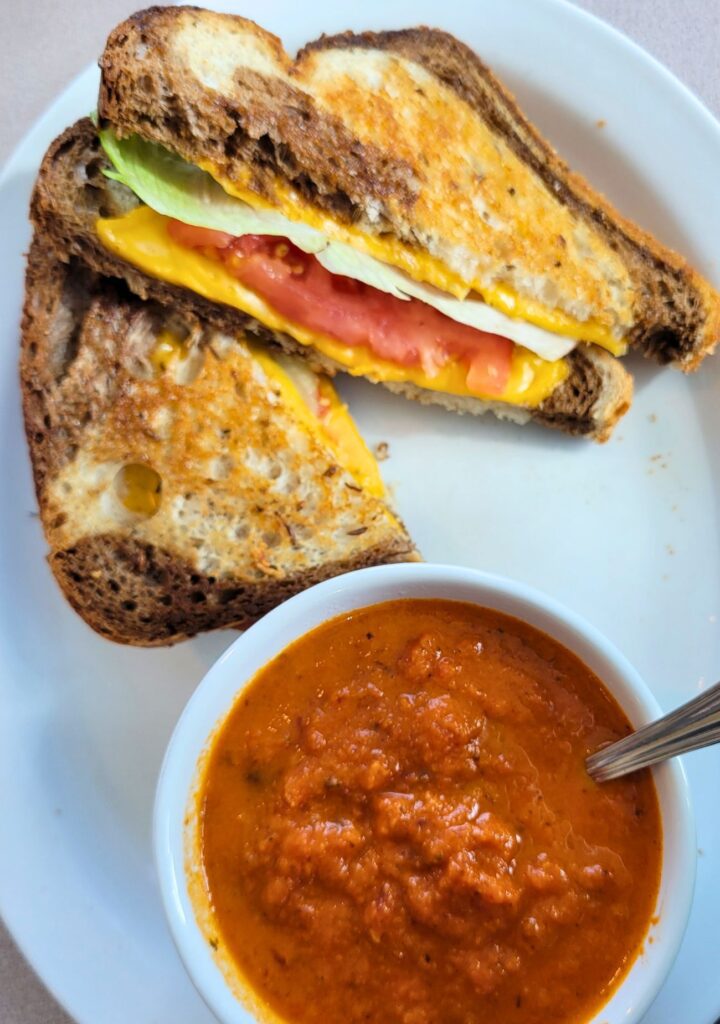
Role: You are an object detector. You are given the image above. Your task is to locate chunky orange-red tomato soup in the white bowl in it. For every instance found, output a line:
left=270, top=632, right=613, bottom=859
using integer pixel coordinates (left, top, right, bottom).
left=198, top=600, right=662, bottom=1024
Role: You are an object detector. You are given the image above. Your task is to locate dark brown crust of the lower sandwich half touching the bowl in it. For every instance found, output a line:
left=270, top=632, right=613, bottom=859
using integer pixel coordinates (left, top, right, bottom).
left=20, top=233, right=417, bottom=647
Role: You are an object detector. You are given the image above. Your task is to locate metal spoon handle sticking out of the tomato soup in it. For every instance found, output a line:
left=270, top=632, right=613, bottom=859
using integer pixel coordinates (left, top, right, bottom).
left=585, top=683, right=720, bottom=782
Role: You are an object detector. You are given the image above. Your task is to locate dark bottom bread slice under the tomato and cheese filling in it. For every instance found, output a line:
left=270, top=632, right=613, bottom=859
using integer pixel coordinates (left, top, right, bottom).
left=31, top=119, right=632, bottom=440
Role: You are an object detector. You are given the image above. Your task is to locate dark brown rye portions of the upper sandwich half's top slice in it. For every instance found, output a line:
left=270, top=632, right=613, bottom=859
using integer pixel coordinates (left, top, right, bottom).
left=98, top=7, right=720, bottom=371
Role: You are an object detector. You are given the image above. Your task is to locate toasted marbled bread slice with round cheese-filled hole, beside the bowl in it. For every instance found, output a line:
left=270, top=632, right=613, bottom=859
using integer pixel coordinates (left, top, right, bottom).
left=20, top=234, right=417, bottom=646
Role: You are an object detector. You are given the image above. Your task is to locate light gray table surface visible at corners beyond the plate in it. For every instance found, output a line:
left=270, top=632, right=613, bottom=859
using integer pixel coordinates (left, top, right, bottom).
left=0, top=0, right=720, bottom=1024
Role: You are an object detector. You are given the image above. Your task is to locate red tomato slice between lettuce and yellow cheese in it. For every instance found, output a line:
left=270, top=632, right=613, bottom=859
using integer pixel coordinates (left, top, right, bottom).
left=169, top=221, right=513, bottom=395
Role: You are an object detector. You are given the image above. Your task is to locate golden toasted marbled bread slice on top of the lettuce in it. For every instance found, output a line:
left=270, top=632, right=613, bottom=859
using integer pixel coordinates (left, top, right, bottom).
left=98, top=7, right=720, bottom=370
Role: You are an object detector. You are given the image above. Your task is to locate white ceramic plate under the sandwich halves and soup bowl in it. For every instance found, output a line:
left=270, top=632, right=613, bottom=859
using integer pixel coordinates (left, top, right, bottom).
left=0, top=0, right=720, bottom=1024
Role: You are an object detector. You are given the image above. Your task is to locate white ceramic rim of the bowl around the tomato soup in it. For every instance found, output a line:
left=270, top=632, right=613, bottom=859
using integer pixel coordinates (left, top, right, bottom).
left=153, top=562, right=696, bottom=1024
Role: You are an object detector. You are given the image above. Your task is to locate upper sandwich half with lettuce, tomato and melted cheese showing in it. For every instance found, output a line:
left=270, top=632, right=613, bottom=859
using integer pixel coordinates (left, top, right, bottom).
left=33, top=7, right=720, bottom=440
